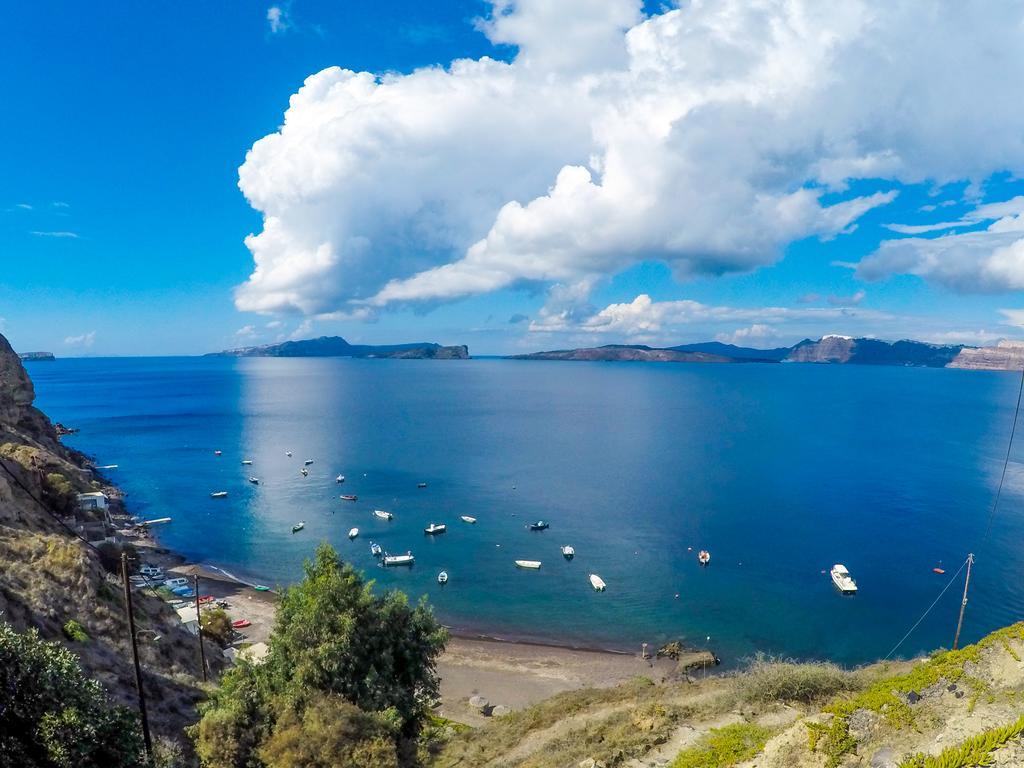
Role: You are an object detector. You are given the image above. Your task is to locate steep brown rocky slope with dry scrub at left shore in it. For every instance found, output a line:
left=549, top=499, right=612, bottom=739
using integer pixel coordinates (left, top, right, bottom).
left=0, top=336, right=212, bottom=762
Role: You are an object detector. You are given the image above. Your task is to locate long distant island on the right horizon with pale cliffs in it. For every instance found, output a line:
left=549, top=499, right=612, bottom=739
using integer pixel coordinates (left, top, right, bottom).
left=510, top=335, right=1024, bottom=371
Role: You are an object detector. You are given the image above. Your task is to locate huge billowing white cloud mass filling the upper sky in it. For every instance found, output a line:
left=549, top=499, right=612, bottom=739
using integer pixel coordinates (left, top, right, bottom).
left=236, top=0, right=1024, bottom=315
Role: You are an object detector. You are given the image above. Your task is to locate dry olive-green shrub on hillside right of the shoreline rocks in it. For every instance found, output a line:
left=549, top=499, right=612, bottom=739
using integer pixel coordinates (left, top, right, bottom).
left=736, top=654, right=863, bottom=705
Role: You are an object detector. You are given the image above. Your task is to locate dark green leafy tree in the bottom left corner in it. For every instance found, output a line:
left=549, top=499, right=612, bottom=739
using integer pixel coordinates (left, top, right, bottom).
left=0, top=624, right=146, bottom=768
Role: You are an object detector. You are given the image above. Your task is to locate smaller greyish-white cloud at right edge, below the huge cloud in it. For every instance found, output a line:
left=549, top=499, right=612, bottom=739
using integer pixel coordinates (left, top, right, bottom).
left=857, top=197, right=1024, bottom=293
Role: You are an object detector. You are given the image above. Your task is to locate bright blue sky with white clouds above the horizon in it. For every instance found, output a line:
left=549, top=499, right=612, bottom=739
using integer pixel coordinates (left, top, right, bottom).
left=0, top=0, right=1024, bottom=356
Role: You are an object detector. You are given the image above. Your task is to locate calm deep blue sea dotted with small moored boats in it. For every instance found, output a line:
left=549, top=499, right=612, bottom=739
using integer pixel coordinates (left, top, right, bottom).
left=30, top=358, right=1024, bottom=664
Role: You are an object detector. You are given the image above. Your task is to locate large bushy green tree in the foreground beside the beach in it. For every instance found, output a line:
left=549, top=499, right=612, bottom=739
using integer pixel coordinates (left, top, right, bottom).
left=189, top=544, right=446, bottom=768
